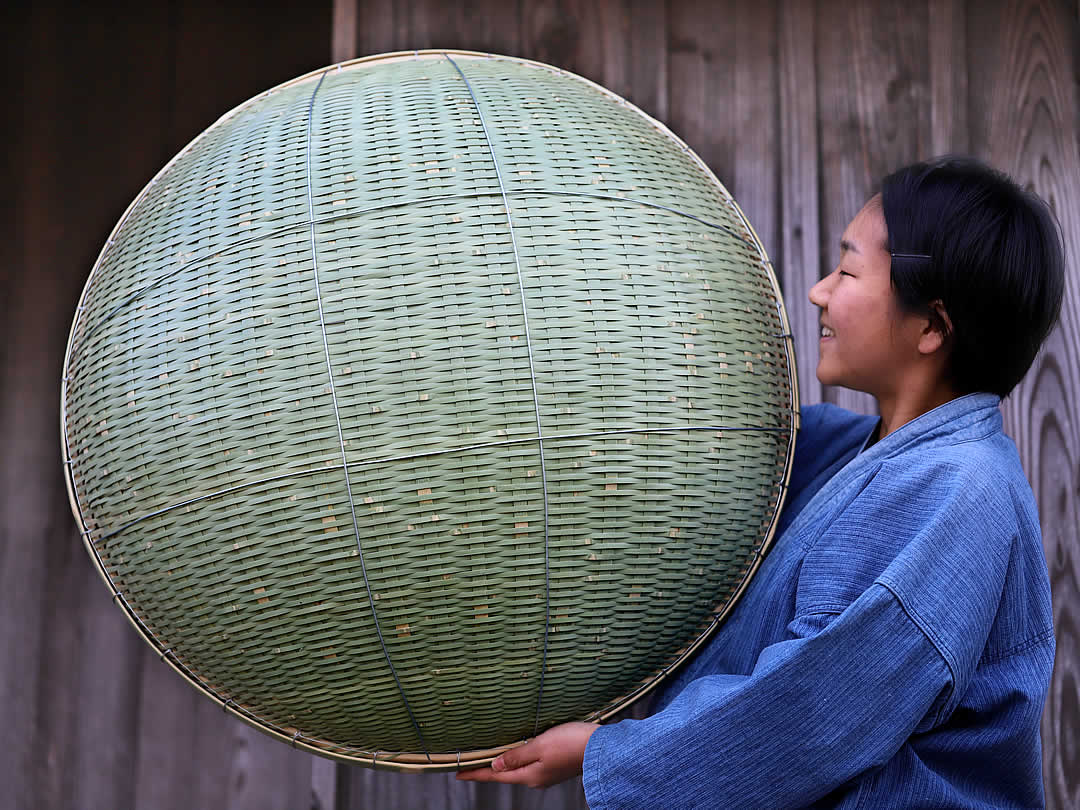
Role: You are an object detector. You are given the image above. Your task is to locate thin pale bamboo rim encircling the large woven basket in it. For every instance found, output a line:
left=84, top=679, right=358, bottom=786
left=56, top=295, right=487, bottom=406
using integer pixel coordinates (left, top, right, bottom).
left=59, top=49, right=799, bottom=772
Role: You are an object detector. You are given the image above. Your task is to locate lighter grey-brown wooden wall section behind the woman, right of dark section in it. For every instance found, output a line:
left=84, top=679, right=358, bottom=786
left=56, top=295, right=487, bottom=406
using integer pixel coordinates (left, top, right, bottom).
left=334, top=0, right=1080, bottom=809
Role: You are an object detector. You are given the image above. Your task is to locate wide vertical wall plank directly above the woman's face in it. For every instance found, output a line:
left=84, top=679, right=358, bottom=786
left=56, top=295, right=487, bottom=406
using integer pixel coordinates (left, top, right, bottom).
left=815, top=0, right=929, bottom=413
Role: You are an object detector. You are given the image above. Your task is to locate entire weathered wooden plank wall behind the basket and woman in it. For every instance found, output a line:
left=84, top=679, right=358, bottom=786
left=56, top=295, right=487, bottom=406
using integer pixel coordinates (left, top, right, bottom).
left=0, top=0, right=1080, bottom=810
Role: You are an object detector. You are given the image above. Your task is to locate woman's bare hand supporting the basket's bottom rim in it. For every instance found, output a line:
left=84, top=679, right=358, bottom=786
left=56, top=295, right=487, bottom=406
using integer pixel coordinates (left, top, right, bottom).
left=458, top=723, right=599, bottom=787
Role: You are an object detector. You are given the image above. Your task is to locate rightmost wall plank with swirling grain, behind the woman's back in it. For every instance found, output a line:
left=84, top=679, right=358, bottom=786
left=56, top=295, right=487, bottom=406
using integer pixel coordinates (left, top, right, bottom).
left=969, top=0, right=1080, bottom=809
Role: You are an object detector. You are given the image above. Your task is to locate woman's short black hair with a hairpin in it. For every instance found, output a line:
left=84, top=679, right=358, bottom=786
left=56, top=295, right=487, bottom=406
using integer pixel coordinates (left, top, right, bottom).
left=881, top=157, right=1065, bottom=396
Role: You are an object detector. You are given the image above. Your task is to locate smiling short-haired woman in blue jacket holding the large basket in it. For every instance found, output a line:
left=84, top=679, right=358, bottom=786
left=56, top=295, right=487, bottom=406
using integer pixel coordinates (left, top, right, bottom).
left=464, top=159, right=1064, bottom=810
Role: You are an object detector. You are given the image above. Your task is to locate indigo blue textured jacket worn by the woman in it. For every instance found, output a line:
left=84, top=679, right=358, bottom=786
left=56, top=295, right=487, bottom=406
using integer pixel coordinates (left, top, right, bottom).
left=584, top=394, right=1054, bottom=810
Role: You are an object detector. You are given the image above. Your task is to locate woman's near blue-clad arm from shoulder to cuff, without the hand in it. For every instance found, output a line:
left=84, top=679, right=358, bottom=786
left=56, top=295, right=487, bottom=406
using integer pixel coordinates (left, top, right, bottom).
left=583, top=456, right=1013, bottom=810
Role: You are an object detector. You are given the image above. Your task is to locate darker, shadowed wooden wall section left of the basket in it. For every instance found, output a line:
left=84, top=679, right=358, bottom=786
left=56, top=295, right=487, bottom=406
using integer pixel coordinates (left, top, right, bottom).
left=0, top=0, right=333, bottom=810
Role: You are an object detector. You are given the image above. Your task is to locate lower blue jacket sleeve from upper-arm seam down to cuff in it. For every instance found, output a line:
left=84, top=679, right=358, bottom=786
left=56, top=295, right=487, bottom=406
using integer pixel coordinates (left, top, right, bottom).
left=584, top=584, right=950, bottom=810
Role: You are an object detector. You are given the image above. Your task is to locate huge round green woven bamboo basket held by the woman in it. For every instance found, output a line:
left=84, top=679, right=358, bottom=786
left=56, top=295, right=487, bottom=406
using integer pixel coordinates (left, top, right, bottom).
left=60, top=51, right=798, bottom=770
